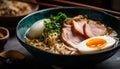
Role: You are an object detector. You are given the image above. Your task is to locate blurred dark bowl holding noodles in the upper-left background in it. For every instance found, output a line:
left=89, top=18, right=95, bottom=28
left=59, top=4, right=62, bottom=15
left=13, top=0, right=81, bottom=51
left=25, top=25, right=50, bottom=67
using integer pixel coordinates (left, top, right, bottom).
left=0, top=0, right=39, bottom=28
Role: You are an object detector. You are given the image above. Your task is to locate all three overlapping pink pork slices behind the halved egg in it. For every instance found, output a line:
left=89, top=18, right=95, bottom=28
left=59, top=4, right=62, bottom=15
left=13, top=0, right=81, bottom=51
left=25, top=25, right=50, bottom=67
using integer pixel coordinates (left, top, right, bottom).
left=61, top=19, right=106, bottom=48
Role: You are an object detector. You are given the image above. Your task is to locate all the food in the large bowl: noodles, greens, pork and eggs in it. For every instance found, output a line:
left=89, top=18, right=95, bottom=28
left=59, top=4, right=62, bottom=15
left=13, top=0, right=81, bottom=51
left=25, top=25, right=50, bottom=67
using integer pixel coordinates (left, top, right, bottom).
left=25, top=12, right=119, bottom=55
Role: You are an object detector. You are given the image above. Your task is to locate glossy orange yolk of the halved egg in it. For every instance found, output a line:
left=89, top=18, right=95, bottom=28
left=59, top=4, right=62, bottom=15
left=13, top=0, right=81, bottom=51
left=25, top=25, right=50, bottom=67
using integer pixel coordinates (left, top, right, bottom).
left=86, top=38, right=107, bottom=48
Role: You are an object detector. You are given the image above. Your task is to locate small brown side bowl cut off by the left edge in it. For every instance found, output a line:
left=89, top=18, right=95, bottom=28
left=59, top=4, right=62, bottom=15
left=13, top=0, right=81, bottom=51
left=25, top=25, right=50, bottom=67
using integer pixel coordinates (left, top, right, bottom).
left=0, top=27, right=9, bottom=50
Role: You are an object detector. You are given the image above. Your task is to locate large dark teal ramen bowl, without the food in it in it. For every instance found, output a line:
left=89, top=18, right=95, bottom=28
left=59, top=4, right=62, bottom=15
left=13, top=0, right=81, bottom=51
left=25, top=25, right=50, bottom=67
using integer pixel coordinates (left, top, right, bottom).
left=16, top=7, right=120, bottom=66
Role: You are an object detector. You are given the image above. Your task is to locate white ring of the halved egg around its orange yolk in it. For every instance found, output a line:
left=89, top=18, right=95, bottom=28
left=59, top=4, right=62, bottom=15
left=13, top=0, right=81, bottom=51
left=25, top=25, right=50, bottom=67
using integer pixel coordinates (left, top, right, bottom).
left=76, top=36, right=116, bottom=53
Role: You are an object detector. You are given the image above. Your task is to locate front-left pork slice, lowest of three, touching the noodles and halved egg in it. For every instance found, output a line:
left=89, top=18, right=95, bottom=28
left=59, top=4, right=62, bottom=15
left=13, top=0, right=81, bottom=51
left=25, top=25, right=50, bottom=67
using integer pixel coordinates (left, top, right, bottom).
left=61, top=27, right=85, bottom=48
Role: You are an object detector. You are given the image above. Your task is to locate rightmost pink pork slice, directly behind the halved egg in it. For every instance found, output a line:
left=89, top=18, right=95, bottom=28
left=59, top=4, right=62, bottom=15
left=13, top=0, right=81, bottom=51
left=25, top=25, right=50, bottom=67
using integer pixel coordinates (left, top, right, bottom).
left=84, top=20, right=107, bottom=37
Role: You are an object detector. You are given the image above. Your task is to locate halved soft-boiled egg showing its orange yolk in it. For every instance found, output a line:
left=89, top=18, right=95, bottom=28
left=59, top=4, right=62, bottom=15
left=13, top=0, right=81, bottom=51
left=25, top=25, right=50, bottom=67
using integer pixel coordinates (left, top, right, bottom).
left=76, top=36, right=116, bottom=54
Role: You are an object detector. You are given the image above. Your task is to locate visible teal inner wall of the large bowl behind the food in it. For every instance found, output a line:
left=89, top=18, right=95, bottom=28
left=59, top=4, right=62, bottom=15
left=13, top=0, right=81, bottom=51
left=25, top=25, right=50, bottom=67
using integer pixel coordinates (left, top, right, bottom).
left=16, top=7, right=120, bottom=42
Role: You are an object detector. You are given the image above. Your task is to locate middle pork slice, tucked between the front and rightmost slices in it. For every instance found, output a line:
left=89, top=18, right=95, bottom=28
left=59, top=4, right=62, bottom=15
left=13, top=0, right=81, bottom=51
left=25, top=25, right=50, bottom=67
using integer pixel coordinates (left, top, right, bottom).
left=72, top=20, right=87, bottom=35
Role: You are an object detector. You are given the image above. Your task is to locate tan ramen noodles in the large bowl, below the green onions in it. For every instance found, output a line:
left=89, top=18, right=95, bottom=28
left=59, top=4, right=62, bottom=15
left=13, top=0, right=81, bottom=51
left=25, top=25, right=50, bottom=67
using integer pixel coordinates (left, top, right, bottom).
left=26, top=33, right=76, bottom=54
